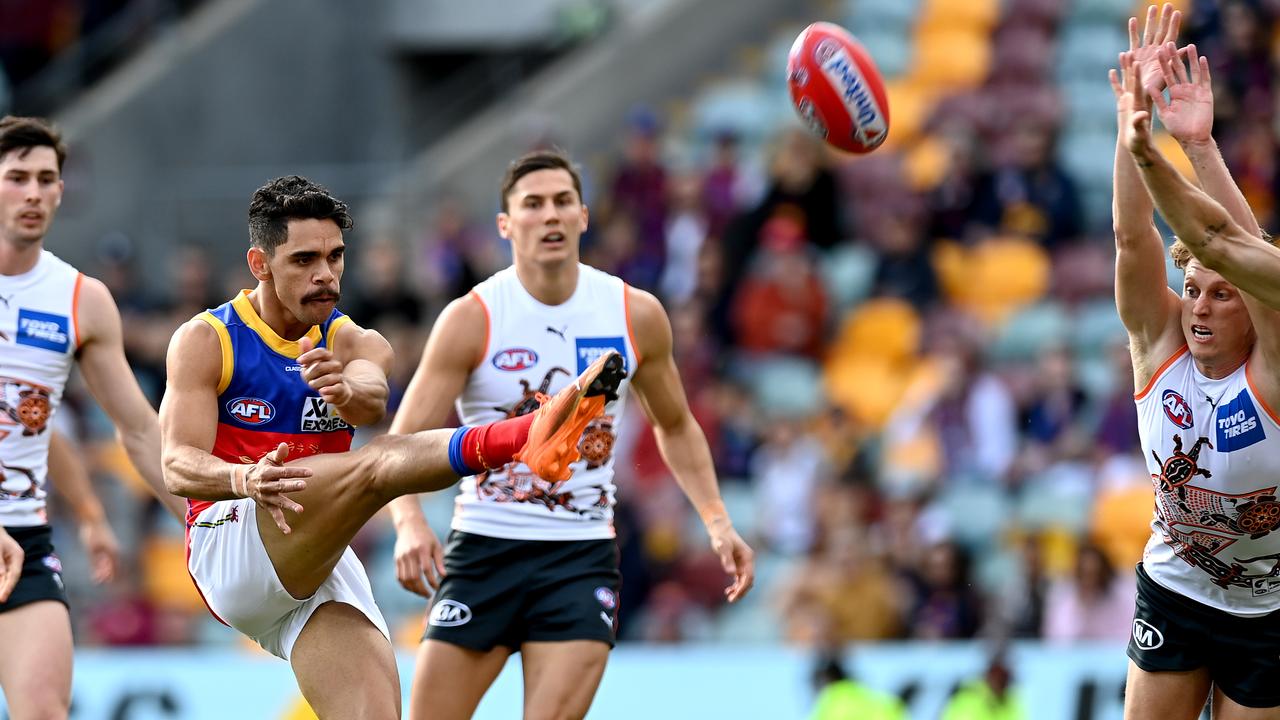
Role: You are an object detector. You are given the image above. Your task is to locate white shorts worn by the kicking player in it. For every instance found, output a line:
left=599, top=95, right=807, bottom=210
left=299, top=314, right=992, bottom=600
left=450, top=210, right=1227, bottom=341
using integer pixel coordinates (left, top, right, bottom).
left=187, top=497, right=390, bottom=660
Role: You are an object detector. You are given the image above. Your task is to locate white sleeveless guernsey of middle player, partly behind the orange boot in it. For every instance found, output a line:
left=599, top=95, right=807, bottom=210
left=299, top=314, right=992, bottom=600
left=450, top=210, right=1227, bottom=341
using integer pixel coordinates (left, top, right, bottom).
left=453, top=265, right=640, bottom=541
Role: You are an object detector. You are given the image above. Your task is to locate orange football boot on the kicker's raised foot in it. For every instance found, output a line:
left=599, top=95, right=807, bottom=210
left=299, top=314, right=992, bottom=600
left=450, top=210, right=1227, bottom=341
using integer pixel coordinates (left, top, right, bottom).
left=515, top=351, right=627, bottom=483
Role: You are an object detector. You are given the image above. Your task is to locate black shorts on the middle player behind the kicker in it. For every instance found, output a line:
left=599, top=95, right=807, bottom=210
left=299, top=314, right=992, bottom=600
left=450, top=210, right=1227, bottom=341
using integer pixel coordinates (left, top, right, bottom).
left=424, top=530, right=622, bottom=651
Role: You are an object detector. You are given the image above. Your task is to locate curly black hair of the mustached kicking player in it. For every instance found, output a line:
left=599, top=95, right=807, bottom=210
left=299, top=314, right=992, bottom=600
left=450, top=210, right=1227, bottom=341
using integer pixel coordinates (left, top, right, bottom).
left=248, top=176, right=352, bottom=255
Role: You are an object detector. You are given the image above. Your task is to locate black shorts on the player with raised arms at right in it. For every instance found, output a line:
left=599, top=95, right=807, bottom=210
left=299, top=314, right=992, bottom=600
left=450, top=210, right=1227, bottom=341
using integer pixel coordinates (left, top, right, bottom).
left=1129, top=562, right=1280, bottom=707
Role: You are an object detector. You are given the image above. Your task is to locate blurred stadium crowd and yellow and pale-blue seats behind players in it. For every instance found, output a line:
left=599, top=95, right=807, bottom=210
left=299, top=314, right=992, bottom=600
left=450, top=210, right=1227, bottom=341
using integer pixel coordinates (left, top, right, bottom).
left=12, top=0, right=1280, bottom=648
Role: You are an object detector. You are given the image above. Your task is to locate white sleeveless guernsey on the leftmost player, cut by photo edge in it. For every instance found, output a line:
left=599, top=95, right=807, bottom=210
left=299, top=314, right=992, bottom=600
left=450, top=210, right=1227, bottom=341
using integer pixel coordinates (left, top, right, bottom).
left=0, top=250, right=83, bottom=527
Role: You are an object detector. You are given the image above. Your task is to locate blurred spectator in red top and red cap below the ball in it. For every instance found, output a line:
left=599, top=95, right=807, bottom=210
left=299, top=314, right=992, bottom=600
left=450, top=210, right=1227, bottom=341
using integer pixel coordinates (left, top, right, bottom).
left=732, top=215, right=829, bottom=360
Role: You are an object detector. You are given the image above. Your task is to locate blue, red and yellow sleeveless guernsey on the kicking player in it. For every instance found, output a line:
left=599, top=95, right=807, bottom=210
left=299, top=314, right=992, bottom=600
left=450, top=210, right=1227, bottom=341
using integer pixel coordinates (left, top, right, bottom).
left=187, top=291, right=355, bottom=529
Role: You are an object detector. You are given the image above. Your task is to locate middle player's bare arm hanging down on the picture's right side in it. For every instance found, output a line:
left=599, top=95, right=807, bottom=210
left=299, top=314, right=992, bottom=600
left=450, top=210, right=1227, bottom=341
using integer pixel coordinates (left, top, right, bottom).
left=627, top=287, right=755, bottom=602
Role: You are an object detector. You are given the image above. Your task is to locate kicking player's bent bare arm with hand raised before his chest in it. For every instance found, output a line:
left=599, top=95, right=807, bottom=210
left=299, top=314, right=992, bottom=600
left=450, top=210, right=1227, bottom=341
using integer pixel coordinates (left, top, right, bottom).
left=298, top=323, right=394, bottom=425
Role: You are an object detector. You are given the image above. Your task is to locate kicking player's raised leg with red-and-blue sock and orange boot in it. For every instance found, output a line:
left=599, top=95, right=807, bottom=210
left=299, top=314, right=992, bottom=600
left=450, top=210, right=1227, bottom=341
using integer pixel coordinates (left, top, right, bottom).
left=256, top=352, right=626, bottom=598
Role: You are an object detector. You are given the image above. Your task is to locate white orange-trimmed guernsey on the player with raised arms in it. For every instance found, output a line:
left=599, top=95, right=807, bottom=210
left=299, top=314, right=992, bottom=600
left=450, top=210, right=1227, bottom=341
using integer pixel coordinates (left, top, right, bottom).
left=1134, top=346, right=1280, bottom=616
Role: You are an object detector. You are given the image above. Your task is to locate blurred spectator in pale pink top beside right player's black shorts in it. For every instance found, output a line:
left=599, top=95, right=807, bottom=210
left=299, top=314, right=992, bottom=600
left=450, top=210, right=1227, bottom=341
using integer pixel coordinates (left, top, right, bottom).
left=1044, top=543, right=1135, bottom=642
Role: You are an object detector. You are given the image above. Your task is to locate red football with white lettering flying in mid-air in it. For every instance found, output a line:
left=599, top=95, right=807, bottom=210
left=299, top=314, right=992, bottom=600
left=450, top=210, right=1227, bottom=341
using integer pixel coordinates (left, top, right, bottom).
left=787, top=23, right=888, bottom=152
